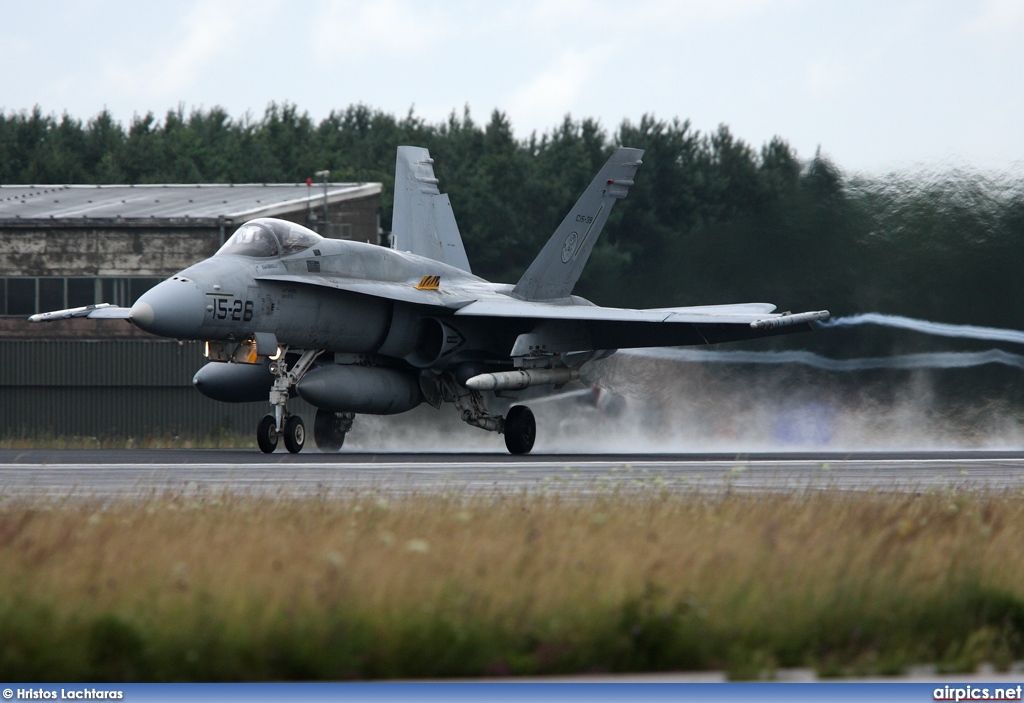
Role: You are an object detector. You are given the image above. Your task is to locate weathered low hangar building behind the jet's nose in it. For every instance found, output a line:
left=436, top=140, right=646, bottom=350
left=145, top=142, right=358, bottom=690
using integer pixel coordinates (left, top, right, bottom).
left=0, top=183, right=381, bottom=438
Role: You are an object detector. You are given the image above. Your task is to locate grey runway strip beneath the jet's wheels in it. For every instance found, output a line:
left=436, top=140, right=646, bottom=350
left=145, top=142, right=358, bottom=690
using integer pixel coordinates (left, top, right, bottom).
left=0, top=449, right=1024, bottom=500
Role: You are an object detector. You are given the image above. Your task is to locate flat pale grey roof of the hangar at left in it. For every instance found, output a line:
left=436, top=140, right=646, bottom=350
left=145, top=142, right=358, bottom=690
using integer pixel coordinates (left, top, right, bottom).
left=0, top=183, right=381, bottom=224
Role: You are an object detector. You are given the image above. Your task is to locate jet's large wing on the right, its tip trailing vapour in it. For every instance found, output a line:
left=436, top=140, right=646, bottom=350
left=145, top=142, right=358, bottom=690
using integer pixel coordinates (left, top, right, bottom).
left=455, top=298, right=828, bottom=355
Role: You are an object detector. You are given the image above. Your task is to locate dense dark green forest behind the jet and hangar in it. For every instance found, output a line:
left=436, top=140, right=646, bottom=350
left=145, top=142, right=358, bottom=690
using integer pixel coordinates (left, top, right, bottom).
left=6, top=104, right=1024, bottom=355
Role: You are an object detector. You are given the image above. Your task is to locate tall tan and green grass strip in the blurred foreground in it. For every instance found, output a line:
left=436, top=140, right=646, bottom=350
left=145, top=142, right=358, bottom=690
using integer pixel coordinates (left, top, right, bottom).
left=0, top=491, right=1024, bottom=680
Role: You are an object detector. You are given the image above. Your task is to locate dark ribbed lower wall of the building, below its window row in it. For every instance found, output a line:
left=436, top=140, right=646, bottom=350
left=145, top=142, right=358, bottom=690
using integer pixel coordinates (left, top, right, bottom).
left=0, top=339, right=315, bottom=441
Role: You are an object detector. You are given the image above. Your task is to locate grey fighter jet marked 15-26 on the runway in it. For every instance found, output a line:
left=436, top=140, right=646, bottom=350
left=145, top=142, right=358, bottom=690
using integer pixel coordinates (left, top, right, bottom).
left=30, top=146, right=828, bottom=454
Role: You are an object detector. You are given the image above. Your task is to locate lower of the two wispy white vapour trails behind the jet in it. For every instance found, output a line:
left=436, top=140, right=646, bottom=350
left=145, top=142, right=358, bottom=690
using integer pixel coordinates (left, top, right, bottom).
left=618, top=348, right=1024, bottom=371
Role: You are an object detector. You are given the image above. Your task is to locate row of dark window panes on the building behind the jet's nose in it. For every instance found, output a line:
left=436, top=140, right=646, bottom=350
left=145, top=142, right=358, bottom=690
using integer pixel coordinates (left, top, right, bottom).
left=0, top=276, right=162, bottom=317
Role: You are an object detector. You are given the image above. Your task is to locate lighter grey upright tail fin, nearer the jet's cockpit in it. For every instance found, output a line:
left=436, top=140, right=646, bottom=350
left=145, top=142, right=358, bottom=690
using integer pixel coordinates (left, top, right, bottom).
left=391, top=146, right=470, bottom=271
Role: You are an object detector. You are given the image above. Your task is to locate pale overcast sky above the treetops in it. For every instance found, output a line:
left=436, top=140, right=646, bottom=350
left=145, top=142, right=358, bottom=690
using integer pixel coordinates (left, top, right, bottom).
left=0, top=0, right=1024, bottom=173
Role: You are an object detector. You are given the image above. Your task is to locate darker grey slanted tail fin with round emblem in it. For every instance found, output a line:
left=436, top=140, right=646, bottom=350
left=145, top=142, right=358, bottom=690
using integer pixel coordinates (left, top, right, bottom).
left=512, top=146, right=643, bottom=300
